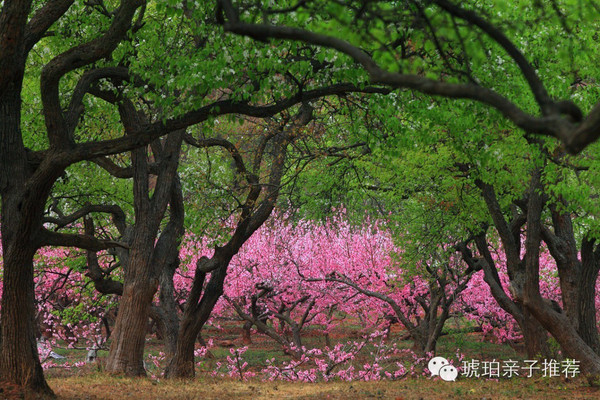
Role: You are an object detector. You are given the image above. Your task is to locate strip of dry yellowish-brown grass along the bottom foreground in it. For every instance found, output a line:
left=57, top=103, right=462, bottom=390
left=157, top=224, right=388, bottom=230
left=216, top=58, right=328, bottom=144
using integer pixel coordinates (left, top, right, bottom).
left=49, top=374, right=600, bottom=400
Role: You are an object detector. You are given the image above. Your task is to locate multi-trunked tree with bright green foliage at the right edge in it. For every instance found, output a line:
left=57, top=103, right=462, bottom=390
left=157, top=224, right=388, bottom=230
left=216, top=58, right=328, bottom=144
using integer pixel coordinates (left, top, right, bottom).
left=364, top=101, right=598, bottom=375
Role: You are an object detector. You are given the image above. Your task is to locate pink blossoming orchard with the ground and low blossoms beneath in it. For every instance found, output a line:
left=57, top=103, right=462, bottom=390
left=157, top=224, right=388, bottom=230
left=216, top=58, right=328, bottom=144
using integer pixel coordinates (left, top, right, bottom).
left=0, top=211, right=600, bottom=382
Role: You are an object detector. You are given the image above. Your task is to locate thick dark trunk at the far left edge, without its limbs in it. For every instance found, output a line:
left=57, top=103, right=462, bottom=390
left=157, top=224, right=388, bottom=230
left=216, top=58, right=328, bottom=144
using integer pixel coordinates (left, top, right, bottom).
left=0, top=79, right=54, bottom=398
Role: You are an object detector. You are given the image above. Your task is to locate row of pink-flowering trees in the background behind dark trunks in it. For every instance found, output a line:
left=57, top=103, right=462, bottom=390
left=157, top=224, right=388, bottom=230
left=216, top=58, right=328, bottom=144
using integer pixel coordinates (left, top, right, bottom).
left=0, top=213, right=600, bottom=380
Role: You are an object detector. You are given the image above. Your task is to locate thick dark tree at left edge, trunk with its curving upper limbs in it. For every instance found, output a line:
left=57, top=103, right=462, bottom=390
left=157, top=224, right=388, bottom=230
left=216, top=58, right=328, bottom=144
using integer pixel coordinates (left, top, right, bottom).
left=0, top=1, right=146, bottom=395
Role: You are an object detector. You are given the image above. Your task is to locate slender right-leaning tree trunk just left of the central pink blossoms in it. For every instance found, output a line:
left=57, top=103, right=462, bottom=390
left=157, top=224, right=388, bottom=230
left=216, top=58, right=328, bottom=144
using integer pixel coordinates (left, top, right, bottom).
left=165, top=105, right=312, bottom=377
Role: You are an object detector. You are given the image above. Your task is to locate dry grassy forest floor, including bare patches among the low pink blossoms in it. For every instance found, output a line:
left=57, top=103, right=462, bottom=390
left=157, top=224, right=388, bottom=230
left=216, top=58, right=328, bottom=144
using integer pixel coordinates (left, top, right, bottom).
left=46, top=325, right=600, bottom=400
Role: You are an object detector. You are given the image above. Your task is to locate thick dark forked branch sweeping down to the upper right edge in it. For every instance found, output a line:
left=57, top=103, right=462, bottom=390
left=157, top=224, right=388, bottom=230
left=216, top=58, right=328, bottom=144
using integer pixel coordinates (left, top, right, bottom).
left=219, top=0, right=600, bottom=153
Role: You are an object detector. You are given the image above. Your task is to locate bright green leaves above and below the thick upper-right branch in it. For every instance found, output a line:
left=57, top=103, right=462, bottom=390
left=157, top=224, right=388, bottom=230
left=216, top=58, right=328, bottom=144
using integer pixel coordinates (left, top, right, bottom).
left=274, top=1, right=600, bottom=278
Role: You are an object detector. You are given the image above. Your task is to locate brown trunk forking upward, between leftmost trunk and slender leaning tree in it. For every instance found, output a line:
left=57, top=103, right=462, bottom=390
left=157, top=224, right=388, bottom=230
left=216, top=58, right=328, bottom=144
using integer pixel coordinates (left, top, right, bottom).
left=106, top=132, right=183, bottom=376
